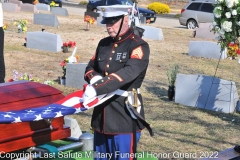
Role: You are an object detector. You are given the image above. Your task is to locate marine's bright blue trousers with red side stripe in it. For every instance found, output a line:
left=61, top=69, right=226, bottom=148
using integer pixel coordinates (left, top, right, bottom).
left=94, top=132, right=141, bottom=160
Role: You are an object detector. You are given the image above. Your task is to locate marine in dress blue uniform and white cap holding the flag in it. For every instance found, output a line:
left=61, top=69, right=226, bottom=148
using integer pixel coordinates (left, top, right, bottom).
left=83, top=5, right=150, bottom=160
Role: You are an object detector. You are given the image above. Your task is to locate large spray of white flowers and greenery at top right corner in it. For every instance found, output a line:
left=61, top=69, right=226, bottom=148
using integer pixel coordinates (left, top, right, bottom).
left=211, top=0, right=240, bottom=56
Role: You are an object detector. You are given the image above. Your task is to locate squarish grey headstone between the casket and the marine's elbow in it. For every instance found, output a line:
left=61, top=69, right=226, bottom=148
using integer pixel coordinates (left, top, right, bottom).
left=66, top=63, right=87, bottom=89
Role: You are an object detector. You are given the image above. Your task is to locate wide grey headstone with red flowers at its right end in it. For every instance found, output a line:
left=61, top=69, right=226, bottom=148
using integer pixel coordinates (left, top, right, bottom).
left=27, top=31, right=63, bottom=52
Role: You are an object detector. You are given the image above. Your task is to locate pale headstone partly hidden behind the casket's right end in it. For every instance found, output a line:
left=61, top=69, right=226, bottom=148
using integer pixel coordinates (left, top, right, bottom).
left=64, top=116, right=82, bottom=139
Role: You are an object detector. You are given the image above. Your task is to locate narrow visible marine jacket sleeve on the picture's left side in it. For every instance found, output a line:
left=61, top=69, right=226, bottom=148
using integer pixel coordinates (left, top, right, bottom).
left=84, top=41, right=102, bottom=83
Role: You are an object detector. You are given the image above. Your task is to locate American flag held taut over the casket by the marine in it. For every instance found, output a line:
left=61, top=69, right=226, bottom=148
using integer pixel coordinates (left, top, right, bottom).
left=0, top=86, right=114, bottom=123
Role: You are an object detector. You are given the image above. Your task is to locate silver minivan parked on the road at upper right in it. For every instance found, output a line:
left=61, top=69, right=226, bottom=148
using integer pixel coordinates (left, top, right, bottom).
left=179, top=0, right=215, bottom=29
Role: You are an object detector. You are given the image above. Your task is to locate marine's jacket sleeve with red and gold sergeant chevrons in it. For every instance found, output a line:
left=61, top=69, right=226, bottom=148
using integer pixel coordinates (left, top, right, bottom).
left=93, top=41, right=150, bottom=95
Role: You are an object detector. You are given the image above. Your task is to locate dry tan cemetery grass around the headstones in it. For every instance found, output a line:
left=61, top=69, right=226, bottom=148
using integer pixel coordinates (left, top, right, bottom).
left=4, top=6, right=240, bottom=159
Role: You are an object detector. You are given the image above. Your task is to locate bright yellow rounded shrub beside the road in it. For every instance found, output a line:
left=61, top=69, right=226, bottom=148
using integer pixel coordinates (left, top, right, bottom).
left=148, top=2, right=170, bottom=14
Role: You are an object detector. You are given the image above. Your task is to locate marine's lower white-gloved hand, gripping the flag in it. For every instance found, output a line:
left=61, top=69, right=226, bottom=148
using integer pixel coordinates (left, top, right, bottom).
left=82, top=84, right=97, bottom=105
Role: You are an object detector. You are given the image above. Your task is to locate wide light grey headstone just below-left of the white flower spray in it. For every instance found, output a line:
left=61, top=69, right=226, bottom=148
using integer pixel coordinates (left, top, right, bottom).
left=188, top=41, right=227, bottom=59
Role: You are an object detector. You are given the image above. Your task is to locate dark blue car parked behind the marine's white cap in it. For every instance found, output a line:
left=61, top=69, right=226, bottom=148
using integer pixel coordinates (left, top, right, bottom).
left=87, top=0, right=156, bottom=23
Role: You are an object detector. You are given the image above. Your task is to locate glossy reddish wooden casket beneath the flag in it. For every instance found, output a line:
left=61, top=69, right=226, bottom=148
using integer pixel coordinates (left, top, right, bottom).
left=0, top=81, right=70, bottom=153
